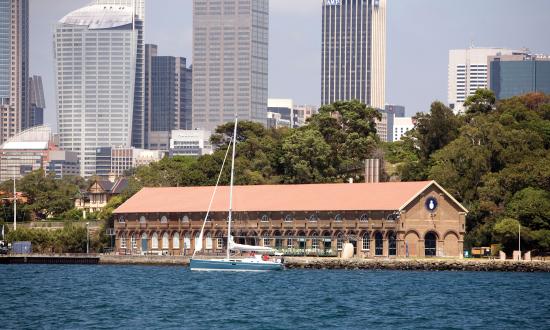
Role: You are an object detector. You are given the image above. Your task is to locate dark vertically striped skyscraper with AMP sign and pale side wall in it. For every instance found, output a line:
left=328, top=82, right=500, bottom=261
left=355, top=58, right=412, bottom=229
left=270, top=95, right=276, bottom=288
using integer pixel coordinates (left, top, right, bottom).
left=321, top=0, right=386, bottom=109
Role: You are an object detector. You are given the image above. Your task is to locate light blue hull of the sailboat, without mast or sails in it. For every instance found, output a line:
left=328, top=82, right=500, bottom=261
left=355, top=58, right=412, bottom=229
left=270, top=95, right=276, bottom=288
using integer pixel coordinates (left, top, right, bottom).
left=189, top=259, right=284, bottom=272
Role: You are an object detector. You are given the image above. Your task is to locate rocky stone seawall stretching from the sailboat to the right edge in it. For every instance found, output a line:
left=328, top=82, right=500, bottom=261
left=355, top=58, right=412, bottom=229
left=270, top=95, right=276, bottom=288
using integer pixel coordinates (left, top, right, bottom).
left=285, top=258, right=550, bottom=272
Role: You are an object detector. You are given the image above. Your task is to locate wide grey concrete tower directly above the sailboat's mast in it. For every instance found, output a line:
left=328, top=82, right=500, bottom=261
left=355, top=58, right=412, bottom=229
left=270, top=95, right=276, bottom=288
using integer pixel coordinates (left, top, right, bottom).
left=193, top=0, right=269, bottom=131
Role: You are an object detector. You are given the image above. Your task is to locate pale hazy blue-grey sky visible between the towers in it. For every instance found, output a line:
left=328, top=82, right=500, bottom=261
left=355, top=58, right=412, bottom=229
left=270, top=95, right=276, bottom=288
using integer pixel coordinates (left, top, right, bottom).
left=30, top=0, right=550, bottom=128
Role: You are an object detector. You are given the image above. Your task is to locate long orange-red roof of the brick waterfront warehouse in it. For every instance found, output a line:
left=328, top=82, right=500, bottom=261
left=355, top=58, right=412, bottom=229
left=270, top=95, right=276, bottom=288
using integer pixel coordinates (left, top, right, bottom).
left=114, top=181, right=435, bottom=213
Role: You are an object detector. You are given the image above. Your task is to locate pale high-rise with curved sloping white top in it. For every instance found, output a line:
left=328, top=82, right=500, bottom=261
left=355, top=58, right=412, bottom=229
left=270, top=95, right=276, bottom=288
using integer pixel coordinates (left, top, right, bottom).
left=54, top=3, right=139, bottom=177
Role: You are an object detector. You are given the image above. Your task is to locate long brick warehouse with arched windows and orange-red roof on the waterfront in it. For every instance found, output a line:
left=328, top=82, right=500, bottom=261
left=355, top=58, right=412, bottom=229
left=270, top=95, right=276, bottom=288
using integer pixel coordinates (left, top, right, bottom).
left=114, top=181, right=468, bottom=257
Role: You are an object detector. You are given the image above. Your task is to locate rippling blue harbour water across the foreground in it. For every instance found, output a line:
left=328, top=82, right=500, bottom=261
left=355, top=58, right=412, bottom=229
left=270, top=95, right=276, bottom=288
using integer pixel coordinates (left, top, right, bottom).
left=0, top=265, right=550, bottom=329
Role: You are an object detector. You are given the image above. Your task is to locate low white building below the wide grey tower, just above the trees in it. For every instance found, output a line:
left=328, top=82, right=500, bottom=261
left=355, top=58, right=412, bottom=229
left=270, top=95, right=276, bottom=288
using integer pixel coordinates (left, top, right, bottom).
left=170, top=130, right=213, bottom=157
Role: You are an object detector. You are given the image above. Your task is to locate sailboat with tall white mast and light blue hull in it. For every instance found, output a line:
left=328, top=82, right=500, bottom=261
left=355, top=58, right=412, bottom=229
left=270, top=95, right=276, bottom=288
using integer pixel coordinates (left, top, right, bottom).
left=189, top=118, right=284, bottom=272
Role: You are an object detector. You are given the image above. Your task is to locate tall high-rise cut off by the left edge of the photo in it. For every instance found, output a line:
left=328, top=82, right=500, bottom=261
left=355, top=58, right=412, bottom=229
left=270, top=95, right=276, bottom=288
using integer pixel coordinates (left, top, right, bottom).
left=0, top=0, right=30, bottom=143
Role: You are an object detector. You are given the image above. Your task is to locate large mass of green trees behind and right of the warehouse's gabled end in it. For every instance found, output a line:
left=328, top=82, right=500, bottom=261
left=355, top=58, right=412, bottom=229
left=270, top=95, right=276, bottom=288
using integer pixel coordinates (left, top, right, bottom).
left=386, top=90, right=550, bottom=252
